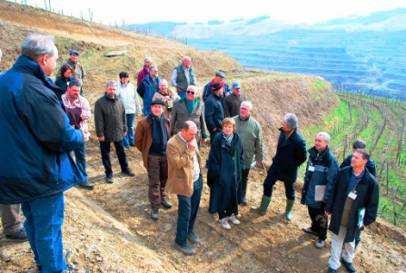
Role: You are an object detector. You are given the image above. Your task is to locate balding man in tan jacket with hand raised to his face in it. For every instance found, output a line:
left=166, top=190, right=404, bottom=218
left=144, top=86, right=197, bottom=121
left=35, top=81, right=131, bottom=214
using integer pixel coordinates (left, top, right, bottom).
left=166, top=120, right=203, bottom=255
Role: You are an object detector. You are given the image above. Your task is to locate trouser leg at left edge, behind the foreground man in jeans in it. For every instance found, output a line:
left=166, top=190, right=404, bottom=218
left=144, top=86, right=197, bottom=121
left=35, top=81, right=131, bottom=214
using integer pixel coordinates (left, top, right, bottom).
left=0, top=204, right=23, bottom=235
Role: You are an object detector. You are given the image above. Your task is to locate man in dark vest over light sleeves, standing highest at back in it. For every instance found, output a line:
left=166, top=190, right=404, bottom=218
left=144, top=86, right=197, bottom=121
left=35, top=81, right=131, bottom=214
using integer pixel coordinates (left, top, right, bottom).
left=171, top=56, right=197, bottom=99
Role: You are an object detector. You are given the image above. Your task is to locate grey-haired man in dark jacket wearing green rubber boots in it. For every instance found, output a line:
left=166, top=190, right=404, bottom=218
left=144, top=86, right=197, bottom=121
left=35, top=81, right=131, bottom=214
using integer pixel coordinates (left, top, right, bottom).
left=259, top=113, right=306, bottom=221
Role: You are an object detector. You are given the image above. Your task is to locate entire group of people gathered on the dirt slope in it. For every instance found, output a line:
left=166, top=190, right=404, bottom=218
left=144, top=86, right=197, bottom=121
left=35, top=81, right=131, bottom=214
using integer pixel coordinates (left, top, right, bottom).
left=0, top=34, right=379, bottom=273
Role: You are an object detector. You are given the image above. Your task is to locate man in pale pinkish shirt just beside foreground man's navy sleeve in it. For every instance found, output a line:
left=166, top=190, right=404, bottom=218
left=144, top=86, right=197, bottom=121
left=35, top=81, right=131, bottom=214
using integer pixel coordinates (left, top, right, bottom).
left=62, top=78, right=93, bottom=190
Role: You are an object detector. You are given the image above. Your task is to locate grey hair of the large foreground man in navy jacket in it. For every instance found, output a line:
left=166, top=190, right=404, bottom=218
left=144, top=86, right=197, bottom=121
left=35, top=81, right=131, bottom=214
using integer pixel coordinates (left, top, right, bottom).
left=21, top=33, right=58, bottom=60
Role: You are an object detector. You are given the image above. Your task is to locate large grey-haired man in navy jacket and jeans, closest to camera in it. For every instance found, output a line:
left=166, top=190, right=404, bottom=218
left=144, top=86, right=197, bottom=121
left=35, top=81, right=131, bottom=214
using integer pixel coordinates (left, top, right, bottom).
left=0, top=34, right=84, bottom=273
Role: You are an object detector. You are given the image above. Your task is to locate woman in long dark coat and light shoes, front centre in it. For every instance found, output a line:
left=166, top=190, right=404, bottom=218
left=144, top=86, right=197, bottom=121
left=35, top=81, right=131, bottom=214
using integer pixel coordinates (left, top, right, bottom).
left=207, top=118, right=243, bottom=229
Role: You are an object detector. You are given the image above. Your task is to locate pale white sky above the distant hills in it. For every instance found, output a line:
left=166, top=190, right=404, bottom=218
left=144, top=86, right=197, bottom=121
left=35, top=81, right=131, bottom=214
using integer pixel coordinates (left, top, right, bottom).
left=12, top=0, right=406, bottom=24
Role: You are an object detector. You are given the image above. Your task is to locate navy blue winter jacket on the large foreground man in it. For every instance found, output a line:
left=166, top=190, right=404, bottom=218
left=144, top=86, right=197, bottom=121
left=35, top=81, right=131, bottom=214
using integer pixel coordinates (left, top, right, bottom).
left=0, top=55, right=85, bottom=204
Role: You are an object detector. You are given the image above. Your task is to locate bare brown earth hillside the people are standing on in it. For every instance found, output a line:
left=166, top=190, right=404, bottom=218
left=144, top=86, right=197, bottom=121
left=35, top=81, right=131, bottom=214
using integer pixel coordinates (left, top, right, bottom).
left=0, top=1, right=406, bottom=273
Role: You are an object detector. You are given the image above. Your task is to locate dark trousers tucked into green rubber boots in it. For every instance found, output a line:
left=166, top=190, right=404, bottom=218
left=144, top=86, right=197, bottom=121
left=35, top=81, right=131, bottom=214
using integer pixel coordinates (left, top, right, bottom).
left=264, top=166, right=296, bottom=200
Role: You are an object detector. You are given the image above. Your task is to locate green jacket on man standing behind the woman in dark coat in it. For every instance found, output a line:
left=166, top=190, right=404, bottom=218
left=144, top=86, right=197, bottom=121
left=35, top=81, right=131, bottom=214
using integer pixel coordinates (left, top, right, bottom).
left=233, top=116, right=264, bottom=169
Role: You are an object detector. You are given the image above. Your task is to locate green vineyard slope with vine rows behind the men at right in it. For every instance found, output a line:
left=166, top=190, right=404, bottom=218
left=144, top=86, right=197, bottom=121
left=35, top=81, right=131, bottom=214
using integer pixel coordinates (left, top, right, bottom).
left=304, top=93, right=406, bottom=227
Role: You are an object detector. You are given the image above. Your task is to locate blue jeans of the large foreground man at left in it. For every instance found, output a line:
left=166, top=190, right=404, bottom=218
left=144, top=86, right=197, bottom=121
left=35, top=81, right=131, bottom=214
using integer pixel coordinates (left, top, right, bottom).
left=21, top=192, right=67, bottom=273
